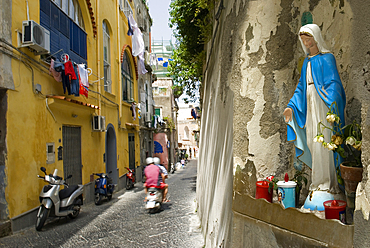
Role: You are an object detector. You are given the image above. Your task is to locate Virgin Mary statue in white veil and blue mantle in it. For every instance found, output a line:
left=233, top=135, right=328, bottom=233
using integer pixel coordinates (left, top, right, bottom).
left=284, top=24, right=346, bottom=211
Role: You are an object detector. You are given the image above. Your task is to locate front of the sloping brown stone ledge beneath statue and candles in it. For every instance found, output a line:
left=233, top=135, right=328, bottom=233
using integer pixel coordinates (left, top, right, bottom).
left=232, top=194, right=354, bottom=247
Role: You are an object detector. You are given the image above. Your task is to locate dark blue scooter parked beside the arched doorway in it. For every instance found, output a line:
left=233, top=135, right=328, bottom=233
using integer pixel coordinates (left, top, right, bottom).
left=93, top=171, right=115, bottom=205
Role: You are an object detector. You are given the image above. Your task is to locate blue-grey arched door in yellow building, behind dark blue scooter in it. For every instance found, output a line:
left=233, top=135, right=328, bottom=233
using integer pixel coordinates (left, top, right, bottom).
left=105, top=124, right=118, bottom=184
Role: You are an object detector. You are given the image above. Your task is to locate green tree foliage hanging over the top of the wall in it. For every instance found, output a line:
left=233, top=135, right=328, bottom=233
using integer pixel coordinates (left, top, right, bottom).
left=169, top=0, right=214, bottom=101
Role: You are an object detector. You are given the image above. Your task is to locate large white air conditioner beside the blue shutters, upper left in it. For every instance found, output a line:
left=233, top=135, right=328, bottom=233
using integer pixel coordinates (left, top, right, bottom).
left=22, top=20, right=50, bottom=54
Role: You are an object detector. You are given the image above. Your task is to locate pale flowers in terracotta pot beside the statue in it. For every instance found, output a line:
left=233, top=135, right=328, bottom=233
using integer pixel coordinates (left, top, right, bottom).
left=314, top=102, right=363, bottom=213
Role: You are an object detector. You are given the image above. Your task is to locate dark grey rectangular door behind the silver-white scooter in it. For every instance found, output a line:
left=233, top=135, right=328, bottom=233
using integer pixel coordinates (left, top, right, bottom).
left=63, top=126, right=82, bottom=185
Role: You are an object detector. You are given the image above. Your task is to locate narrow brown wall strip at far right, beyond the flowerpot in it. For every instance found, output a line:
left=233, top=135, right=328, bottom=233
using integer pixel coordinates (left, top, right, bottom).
left=347, top=0, right=370, bottom=247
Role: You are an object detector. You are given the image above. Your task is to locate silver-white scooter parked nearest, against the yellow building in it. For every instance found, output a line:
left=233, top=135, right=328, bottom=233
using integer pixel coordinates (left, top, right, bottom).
left=36, top=167, right=84, bottom=231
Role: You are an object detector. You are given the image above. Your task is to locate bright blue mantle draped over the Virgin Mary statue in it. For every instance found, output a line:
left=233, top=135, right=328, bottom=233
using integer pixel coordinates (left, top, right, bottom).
left=287, top=53, right=346, bottom=168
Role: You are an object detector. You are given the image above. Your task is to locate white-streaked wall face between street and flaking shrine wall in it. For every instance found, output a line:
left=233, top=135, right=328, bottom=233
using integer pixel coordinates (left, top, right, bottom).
left=197, top=2, right=234, bottom=247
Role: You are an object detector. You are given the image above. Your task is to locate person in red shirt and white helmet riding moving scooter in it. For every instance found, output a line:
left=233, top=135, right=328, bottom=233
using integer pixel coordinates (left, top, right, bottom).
left=144, top=157, right=168, bottom=201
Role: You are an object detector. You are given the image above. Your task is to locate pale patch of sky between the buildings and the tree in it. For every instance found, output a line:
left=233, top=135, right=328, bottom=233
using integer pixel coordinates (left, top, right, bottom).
left=148, top=0, right=172, bottom=40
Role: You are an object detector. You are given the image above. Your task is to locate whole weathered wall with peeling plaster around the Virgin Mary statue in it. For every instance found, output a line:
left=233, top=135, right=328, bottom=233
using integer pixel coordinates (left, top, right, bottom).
left=197, top=0, right=370, bottom=247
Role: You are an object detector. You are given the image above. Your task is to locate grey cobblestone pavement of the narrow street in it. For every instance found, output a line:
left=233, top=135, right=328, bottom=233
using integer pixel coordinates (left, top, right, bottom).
left=0, top=160, right=203, bottom=248
